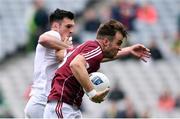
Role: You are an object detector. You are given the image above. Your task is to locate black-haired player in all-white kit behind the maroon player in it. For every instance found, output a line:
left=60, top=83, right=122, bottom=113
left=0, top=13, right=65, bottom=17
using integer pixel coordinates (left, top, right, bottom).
left=24, top=9, right=75, bottom=118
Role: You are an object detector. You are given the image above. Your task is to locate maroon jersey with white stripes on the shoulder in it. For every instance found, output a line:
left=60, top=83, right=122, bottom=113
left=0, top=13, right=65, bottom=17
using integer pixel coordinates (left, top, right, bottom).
left=48, top=41, right=103, bottom=106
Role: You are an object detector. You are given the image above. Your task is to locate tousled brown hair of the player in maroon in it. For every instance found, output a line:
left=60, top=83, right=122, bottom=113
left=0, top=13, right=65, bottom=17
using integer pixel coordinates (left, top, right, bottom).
left=96, top=19, right=128, bottom=41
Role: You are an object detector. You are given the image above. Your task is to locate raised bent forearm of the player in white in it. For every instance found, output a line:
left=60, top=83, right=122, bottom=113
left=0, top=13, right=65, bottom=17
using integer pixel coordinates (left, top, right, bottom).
left=38, top=35, right=69, bottom=50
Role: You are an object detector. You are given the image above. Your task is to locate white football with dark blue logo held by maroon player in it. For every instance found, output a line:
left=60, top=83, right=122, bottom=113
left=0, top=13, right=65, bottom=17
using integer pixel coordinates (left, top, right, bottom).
left=89, top=72, right=110, bottom=91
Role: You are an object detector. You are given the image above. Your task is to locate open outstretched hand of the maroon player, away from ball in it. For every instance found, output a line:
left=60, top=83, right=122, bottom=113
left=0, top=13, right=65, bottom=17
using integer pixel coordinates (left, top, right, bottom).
left=130, top=44, right=151, bottom=62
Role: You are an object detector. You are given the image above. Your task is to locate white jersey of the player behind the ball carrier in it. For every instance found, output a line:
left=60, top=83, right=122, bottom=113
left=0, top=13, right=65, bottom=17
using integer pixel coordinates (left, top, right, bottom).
left=30, top=30, right=61, bottom=104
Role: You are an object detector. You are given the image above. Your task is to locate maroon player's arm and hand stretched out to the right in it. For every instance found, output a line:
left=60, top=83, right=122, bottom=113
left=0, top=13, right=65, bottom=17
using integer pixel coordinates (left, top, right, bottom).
left=103, top=44, right=151, bottom=62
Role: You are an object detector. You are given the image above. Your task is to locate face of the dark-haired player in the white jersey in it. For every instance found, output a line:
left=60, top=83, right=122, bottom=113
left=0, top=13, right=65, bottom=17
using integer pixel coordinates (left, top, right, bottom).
left=59, top=18, right=75, bottom=39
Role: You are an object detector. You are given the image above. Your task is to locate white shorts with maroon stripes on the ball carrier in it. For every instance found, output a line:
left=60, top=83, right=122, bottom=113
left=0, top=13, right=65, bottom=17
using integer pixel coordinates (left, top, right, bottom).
left=44, top=101, right=82, bottom=118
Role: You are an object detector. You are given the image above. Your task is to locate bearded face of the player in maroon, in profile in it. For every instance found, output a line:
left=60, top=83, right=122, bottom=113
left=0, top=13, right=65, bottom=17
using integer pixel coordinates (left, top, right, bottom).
left=104, top=32, right=123, bottom=58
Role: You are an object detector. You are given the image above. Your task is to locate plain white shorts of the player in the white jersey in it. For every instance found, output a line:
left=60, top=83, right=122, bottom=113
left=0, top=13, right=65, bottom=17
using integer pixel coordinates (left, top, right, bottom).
left=24, top=96, right=46, bottom=118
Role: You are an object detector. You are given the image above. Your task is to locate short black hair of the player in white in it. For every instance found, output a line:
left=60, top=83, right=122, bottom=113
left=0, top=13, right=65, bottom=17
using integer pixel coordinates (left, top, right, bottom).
left=49, top=8, right=74, bottom=25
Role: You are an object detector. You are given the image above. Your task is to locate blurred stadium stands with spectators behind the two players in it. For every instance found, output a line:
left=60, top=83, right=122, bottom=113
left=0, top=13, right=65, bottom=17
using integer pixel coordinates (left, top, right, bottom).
left=0, top=0, right=180, bottom=118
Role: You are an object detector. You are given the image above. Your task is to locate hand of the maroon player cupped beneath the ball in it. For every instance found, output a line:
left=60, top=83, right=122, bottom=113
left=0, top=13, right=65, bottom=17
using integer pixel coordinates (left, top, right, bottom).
left=91, top=88, right=110, bottom=103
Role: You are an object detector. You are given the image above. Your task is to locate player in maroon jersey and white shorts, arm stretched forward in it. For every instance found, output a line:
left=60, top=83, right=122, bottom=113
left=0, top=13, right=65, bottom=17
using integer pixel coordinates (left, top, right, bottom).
left=44, top=20, right=150, bottom=118
